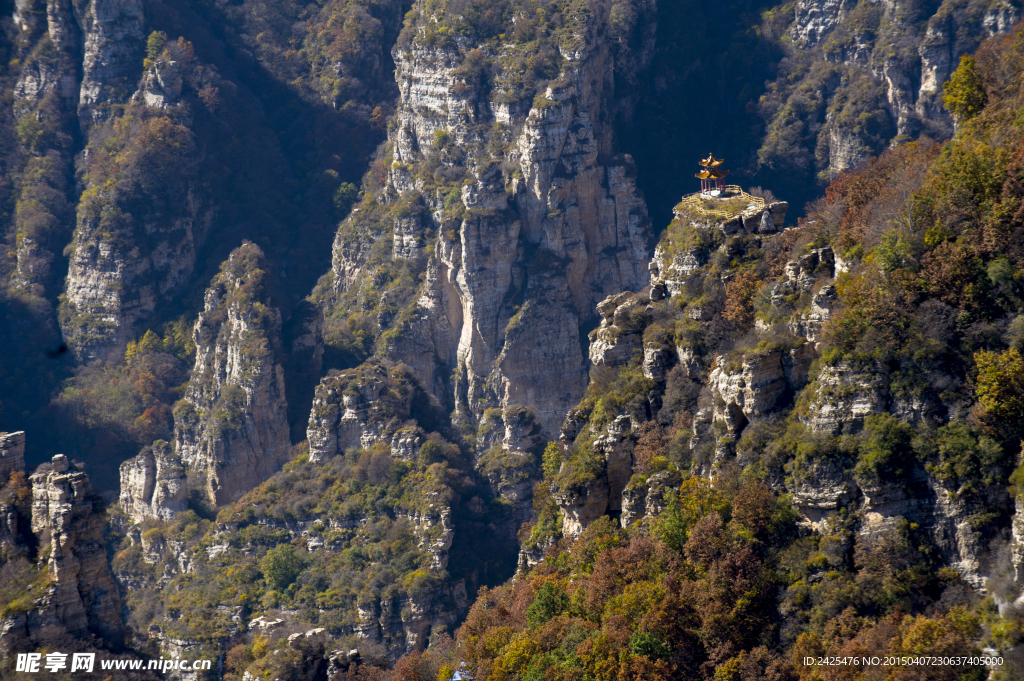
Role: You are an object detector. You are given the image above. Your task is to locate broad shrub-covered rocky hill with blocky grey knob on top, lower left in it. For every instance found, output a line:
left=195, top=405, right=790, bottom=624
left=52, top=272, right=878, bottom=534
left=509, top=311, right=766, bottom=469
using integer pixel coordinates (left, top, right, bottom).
left=116, top=363, right=495, bottom=661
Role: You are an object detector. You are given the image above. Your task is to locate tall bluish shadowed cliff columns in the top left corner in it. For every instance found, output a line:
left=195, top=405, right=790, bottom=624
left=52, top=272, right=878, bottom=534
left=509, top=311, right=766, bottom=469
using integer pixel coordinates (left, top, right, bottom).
left=13, top=0, right=143, bottom=305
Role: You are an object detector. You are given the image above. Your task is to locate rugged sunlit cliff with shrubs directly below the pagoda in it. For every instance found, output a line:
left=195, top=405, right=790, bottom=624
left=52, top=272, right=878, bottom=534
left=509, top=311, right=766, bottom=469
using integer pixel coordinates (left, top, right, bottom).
left=540, top=138, right=1019, bottom=610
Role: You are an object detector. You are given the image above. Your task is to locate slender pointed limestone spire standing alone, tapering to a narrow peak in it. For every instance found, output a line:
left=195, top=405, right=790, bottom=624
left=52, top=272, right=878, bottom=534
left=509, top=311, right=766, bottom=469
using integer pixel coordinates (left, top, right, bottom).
left=174, top=244, right=291, bottom=506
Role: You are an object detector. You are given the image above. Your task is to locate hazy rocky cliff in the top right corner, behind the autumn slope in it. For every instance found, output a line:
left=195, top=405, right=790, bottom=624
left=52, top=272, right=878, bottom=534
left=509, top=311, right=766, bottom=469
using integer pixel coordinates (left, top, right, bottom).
left=760, top=0, right=1021, bottom=178
